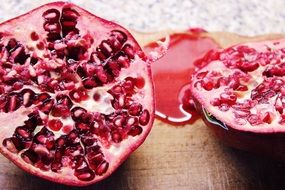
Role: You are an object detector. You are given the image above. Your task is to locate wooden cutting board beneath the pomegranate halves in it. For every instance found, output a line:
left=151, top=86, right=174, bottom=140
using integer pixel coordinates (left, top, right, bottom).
left=0, top=31, right=285, bottom=190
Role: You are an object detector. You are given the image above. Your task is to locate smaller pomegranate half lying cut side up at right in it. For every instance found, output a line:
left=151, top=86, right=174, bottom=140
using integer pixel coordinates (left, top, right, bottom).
left=191, top=39, right=285, bottom=160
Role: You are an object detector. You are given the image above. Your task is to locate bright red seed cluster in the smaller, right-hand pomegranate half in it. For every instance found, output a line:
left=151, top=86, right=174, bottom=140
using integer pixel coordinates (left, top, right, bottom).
left=194, top=43, right=285, bottom=125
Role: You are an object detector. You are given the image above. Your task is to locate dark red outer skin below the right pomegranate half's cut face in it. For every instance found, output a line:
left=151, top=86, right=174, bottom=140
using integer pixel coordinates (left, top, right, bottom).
left=193, top=98, right=285, bottom=161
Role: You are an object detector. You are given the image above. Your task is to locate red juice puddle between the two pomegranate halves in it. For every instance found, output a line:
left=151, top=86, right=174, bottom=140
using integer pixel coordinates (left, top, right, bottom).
left=145, top=31, right=219, bottom=125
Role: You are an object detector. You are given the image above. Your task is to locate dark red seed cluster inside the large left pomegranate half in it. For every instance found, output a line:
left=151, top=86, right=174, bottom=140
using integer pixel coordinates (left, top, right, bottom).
left=0, top=7, right=150, bottom=181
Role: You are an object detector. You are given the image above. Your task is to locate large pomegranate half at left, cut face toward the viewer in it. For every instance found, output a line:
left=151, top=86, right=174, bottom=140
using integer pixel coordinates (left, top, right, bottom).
left=0, top=2, right=154, bottom=186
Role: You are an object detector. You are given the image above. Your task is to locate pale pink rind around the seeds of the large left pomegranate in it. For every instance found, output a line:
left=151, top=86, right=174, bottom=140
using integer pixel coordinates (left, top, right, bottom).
left=0, top=2, right=154, bottom=186
